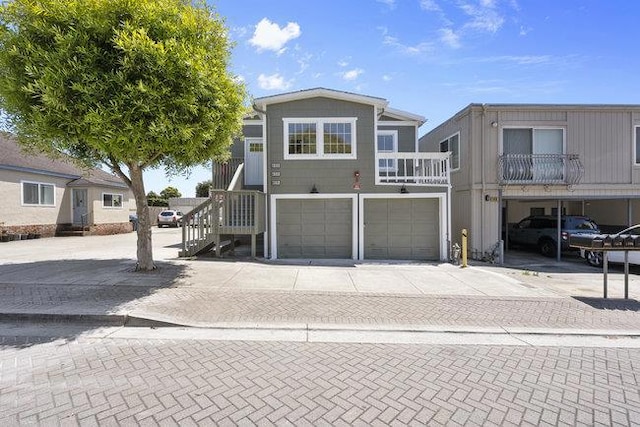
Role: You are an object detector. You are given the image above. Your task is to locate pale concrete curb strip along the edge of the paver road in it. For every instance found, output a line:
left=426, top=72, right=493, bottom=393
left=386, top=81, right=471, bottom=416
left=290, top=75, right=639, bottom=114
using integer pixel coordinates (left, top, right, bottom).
left=0, top=313, right=640, bottom=347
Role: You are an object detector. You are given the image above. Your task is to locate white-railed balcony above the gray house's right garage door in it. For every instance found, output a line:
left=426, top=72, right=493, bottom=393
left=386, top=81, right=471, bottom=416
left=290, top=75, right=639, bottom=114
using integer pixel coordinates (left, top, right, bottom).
left=376, top=153, right=449, bottom=185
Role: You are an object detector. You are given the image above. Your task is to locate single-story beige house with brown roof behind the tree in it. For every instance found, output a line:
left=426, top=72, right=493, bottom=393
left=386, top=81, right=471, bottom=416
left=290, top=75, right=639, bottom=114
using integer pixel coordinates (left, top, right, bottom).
left=0, top=134, right=135, bottom=237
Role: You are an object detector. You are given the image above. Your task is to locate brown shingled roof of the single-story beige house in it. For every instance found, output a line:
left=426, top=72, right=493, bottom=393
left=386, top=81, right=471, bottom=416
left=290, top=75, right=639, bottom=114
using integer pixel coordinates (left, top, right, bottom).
left=0, top=134, right=127, bottom=188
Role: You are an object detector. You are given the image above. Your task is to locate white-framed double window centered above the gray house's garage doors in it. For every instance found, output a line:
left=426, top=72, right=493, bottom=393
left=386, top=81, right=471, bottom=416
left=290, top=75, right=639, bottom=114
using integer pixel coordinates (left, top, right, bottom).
left=283, top=117, right=356, bottom=159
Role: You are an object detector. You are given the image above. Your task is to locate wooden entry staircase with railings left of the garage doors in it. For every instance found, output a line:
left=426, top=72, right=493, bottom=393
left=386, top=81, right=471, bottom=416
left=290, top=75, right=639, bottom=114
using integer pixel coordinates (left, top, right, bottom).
left=179, top=190, right=266, bottom=257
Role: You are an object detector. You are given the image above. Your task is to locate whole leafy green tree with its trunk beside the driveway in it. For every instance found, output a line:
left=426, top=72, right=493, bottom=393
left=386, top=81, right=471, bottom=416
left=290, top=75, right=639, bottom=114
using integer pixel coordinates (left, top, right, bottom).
left=0, top=0, right=245, bottom=270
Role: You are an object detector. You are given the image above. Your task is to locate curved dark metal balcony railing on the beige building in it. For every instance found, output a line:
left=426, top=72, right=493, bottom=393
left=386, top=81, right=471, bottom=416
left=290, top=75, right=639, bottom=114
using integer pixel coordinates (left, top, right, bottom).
left=498, top=154, right=584, bottom=185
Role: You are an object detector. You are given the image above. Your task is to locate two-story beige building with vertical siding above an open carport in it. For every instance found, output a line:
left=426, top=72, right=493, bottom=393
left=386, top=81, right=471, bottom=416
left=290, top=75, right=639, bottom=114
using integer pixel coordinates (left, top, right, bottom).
left=420, top=104, right=640, bottom=260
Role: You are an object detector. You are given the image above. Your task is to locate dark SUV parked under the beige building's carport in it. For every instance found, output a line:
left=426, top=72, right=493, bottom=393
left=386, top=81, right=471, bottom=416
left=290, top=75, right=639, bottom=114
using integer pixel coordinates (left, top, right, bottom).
left=509, top=215, right=600, bottom=257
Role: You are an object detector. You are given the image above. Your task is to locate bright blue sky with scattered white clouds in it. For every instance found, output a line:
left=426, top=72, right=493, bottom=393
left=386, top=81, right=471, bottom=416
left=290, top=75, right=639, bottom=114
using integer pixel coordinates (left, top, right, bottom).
left=145, top=0, right=640, bottom=196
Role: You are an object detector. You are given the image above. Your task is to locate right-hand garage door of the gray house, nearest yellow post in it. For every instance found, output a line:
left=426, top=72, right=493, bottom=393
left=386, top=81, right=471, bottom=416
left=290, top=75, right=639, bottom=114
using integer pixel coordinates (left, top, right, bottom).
left=364, top=198, right=440, bottom=260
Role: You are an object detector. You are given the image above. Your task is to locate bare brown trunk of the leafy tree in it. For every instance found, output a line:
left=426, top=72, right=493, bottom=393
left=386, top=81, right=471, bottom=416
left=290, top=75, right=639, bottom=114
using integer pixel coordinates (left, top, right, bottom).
left=128, top=165, right=156, bottom=271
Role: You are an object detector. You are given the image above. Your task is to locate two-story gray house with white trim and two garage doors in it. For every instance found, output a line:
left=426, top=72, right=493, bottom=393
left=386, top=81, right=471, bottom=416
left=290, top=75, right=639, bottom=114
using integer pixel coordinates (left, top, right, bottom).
left=183, top=88, right=450, bottom=260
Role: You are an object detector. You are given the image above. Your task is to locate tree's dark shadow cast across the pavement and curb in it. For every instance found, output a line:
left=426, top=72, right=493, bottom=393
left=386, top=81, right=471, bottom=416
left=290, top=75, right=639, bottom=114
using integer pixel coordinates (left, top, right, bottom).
left=0, top=259, right=187, bottom=348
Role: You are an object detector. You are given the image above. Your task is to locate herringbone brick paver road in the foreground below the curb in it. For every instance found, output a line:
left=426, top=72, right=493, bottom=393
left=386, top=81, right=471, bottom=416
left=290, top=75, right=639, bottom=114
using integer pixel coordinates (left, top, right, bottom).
left=0, top=332, right=640, bottom=426
